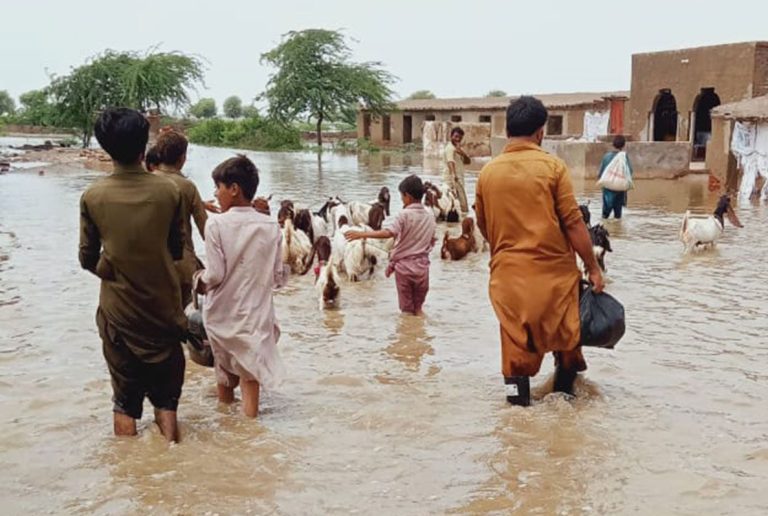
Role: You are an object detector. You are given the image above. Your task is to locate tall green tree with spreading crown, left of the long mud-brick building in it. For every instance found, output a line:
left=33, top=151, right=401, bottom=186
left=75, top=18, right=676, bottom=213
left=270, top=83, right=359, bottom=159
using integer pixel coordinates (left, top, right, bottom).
left=261, top=29, right=395, bottom=147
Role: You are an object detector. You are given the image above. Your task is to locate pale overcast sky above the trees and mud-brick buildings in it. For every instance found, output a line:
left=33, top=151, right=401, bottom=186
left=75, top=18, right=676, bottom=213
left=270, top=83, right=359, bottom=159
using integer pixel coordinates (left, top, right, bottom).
left=0, top=0, right=768, bottom=105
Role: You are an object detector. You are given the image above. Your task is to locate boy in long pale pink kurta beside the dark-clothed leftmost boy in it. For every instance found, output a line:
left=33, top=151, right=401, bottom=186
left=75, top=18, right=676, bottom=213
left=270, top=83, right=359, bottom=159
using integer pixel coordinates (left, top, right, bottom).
left=201, top=156, right=285, bottom=417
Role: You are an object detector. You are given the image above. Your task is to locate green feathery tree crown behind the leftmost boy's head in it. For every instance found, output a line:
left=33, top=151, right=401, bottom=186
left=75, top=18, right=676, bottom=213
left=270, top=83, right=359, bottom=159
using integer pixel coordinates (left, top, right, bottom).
left=47, top=50, right=203, bottom=147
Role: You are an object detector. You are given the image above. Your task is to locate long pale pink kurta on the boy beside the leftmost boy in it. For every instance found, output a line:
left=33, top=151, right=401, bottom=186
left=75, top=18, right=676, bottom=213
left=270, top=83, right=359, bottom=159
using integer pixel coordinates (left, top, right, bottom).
left=203, top=207, right=285, bottom=389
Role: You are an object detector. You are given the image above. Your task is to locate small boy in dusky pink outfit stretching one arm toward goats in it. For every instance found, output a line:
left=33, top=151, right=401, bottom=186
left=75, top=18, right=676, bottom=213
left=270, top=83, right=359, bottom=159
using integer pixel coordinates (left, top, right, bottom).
left=346, top=175, right=436, bottom=315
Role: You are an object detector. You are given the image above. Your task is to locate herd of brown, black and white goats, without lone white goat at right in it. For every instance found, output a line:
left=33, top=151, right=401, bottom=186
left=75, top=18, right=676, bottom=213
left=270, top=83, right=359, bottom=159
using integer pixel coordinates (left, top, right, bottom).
left=258, top=182, right=612, bottom=309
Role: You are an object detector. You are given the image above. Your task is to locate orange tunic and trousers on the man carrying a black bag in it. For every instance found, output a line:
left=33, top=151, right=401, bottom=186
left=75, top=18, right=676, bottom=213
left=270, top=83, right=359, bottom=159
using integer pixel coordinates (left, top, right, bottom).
left=476, top=143, right=586, bottom=376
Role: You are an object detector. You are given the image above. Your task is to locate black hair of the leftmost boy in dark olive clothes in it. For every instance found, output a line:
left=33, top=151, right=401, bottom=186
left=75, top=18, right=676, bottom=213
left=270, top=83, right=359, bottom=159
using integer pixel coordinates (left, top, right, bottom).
left=93, top=108, right=149, bottom=165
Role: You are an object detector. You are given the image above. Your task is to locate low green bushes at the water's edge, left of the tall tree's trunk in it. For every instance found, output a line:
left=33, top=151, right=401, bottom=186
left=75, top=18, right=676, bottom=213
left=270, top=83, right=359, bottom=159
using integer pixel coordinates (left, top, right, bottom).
left=187, top=116, right=301, bottom=151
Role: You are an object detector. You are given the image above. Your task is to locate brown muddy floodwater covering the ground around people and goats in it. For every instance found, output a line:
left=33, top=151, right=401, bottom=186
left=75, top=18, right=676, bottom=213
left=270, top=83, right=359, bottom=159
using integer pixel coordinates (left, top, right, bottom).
left=0, top=147, right=768, bottom=515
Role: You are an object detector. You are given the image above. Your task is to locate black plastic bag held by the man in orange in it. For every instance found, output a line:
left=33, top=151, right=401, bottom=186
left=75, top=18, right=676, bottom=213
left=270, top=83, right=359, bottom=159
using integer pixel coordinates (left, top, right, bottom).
left=579, top=284, right=626, bottom=349
